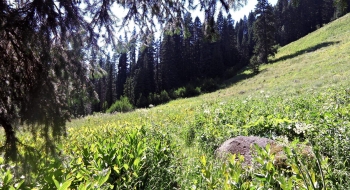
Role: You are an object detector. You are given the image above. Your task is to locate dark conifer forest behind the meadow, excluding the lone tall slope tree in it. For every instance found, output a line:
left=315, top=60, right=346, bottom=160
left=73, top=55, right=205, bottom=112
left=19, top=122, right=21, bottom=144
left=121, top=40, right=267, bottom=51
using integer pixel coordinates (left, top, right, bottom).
left=72, top=0, right=350, bottom=115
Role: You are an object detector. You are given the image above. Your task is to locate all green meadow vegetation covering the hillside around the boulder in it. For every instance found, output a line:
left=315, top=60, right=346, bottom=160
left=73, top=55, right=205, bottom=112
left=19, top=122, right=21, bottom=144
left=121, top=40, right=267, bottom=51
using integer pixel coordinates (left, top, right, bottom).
left=0, top=14, right=350, bottom=189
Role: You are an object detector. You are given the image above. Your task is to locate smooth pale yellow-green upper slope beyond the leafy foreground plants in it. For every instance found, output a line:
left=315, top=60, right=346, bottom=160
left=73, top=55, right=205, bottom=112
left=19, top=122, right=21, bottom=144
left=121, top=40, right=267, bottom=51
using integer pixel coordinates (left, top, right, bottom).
left=78, top=14, right=350, bottom=134
